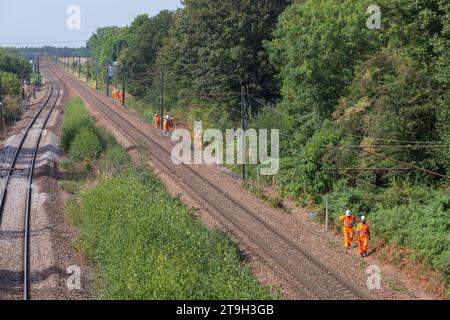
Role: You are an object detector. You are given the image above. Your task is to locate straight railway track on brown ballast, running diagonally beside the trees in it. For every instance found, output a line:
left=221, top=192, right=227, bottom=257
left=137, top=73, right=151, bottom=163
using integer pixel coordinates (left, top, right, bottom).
left=51, top=62, right=370, bottom=300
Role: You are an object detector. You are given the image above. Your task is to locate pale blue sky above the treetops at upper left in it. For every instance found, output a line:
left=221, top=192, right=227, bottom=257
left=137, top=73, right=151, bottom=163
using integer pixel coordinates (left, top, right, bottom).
left=0, top=0, right=181, bottom=47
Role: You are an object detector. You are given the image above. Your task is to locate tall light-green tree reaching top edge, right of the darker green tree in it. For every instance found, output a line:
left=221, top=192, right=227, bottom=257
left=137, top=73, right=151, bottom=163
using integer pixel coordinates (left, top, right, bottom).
left=267, top=0, right=381, bottom=116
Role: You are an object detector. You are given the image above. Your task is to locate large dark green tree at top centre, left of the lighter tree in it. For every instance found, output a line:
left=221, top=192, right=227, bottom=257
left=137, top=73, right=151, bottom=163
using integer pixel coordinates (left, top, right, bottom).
left=161, top=0, right=291, bottom=109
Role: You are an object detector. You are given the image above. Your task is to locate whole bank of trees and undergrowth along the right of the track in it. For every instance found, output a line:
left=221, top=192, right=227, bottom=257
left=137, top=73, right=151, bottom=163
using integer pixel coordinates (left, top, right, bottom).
left=82, top=0, right=450, bottom=287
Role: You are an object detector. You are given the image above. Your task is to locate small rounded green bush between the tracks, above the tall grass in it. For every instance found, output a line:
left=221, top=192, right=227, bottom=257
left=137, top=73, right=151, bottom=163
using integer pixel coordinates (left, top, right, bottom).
left=69, top=128, right=103, bottom=160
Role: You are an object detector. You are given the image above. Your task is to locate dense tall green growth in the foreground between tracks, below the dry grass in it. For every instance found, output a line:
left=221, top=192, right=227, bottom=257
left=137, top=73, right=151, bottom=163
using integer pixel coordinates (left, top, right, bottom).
left=81, top=171, right=273, bottom=299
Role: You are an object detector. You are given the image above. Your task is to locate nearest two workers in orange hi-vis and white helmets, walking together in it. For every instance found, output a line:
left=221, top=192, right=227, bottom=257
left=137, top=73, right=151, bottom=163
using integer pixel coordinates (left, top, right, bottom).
left=339, top=210, right=370, bottom=258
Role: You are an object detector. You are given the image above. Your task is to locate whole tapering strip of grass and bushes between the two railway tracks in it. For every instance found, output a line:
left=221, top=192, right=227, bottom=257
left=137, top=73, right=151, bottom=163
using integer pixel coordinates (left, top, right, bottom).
left=60, top=98, right=279, bottom=299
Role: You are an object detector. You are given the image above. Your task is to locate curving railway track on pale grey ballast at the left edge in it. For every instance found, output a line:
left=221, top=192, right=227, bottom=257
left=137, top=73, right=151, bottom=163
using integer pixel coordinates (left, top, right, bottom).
left=0, top=68, right=60, bottom=300
